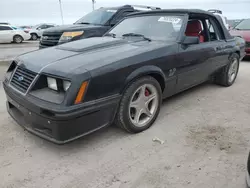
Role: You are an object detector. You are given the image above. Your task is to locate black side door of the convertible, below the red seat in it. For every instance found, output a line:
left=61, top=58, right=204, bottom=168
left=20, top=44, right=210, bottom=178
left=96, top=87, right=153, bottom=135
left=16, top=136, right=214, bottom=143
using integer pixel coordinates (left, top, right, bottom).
left=176, top=18, right=220, bottom=91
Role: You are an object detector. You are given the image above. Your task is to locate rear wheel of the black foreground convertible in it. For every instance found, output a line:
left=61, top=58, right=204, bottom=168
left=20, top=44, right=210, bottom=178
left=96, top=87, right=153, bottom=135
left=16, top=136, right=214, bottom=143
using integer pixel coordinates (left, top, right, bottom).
left=215, top=53, right=240, bottom=87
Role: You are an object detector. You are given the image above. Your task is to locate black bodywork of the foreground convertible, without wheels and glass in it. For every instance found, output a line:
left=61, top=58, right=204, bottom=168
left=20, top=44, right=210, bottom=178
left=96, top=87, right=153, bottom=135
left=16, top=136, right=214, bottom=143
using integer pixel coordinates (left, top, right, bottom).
left=3, top=10, right=244, bottom=143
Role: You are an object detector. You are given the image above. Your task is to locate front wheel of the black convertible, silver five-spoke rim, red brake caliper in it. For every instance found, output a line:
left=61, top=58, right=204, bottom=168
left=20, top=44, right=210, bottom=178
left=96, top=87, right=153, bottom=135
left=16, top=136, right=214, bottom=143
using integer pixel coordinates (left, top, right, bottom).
left=115, top=76, right=162, bottom=133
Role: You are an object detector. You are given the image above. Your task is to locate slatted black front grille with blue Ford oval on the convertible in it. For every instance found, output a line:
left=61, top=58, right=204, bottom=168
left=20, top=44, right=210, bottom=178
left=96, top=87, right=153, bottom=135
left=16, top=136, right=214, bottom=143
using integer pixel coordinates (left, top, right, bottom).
left=10, top=67, right=36, bottom=93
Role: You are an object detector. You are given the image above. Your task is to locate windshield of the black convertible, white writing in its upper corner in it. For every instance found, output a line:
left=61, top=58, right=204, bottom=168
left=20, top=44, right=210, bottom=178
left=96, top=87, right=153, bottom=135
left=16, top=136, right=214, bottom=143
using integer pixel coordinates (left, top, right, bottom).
left=108, top=15, right=183, bottom=41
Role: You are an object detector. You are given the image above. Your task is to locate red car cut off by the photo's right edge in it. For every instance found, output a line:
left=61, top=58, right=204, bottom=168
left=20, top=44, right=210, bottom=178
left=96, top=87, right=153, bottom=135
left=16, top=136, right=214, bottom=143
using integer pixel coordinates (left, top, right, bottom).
left=230, top=19, right=250, bottom=57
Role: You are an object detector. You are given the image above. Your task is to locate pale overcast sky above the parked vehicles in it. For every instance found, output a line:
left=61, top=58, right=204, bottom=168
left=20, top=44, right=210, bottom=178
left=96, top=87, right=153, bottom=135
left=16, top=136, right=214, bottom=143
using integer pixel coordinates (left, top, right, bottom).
left=0, top=0, right=250, bottom=25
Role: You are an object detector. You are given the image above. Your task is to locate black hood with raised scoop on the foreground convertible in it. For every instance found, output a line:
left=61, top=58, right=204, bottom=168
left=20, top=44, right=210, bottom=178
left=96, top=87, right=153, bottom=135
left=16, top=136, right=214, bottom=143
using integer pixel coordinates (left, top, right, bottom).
left=17, top=37, right=172, bottom=77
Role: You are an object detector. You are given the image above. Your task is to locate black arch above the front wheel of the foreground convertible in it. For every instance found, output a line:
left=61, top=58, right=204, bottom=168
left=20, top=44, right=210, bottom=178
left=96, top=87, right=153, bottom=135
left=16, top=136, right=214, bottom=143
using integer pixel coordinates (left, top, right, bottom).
left=121, top=65, right=166, bottom=93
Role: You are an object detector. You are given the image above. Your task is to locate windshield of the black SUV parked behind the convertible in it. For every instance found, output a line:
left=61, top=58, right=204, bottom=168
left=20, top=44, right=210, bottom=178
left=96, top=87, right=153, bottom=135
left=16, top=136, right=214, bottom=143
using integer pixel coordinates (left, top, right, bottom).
left=75, top=9, right=117, bottom=25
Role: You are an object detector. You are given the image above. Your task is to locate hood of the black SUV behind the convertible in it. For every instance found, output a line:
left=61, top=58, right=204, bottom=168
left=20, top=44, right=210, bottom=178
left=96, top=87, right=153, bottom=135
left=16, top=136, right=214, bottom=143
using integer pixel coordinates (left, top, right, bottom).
left=44, top=24, right=105, bottom=33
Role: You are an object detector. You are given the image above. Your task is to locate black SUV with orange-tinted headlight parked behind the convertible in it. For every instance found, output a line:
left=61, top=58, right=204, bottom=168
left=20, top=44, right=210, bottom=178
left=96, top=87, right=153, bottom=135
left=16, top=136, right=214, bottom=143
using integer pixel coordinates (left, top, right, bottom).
left=39, top=5, right=160, bottom=48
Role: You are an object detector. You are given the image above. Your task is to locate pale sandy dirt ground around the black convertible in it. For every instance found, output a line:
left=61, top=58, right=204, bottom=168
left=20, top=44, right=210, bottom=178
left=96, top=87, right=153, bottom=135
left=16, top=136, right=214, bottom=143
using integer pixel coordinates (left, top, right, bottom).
left=0, top=61, right=250, bottom=188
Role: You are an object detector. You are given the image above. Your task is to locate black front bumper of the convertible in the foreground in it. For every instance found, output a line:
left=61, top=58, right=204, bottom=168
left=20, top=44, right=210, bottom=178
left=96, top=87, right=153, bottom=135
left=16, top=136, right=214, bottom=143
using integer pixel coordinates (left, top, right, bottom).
left=4, top=84, right=120, bottom=144
